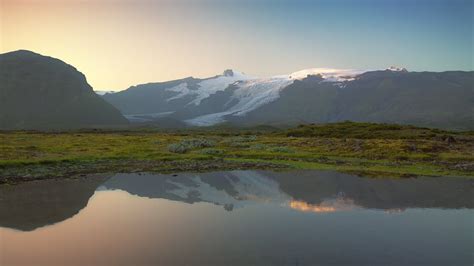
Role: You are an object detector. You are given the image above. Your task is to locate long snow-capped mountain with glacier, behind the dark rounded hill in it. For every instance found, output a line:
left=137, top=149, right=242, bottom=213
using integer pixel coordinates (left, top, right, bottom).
left=103, top=67, right=474, bottom=129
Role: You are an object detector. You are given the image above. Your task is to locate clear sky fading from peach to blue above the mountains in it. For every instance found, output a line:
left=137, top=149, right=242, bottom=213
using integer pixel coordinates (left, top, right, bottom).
left=0, top=0, right=474, bottom=90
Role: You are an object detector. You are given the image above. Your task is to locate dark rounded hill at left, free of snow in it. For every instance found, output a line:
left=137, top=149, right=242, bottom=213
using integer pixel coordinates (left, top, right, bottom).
left=0, top=50, right=128, bottom=129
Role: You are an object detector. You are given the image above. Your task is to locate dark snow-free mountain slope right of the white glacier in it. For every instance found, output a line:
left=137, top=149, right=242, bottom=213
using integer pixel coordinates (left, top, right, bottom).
left=231, top=70, right=474, bottom=129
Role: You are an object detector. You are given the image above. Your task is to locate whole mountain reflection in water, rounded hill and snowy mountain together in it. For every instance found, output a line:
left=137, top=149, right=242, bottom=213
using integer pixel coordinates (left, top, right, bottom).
left=0, top=171, right=474, bottom=231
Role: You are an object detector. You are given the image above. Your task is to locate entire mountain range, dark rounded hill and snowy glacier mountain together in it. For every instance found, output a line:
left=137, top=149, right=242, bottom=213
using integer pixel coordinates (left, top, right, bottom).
left=0, top=50, right=474, bottom=130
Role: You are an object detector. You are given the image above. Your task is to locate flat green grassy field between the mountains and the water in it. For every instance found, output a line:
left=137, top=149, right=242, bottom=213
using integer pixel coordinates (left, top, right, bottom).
left=0, top=122, right=474, bottom=183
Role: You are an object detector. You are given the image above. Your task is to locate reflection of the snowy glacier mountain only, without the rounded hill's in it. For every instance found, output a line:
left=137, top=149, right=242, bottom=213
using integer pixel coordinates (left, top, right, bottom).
left=102, top=171, right=474, bottom=213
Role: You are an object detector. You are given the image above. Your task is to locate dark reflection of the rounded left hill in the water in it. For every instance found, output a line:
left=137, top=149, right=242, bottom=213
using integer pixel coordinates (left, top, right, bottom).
left=0, top=176, right=109, bottom=231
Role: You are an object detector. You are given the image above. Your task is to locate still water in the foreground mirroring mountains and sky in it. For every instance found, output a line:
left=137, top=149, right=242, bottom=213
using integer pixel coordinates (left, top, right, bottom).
left=0, top=171, right=474, bottom=266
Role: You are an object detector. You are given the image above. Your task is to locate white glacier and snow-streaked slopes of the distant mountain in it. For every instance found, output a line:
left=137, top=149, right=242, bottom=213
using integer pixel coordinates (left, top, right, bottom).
left=100, top=68, right=365, bottom=126
